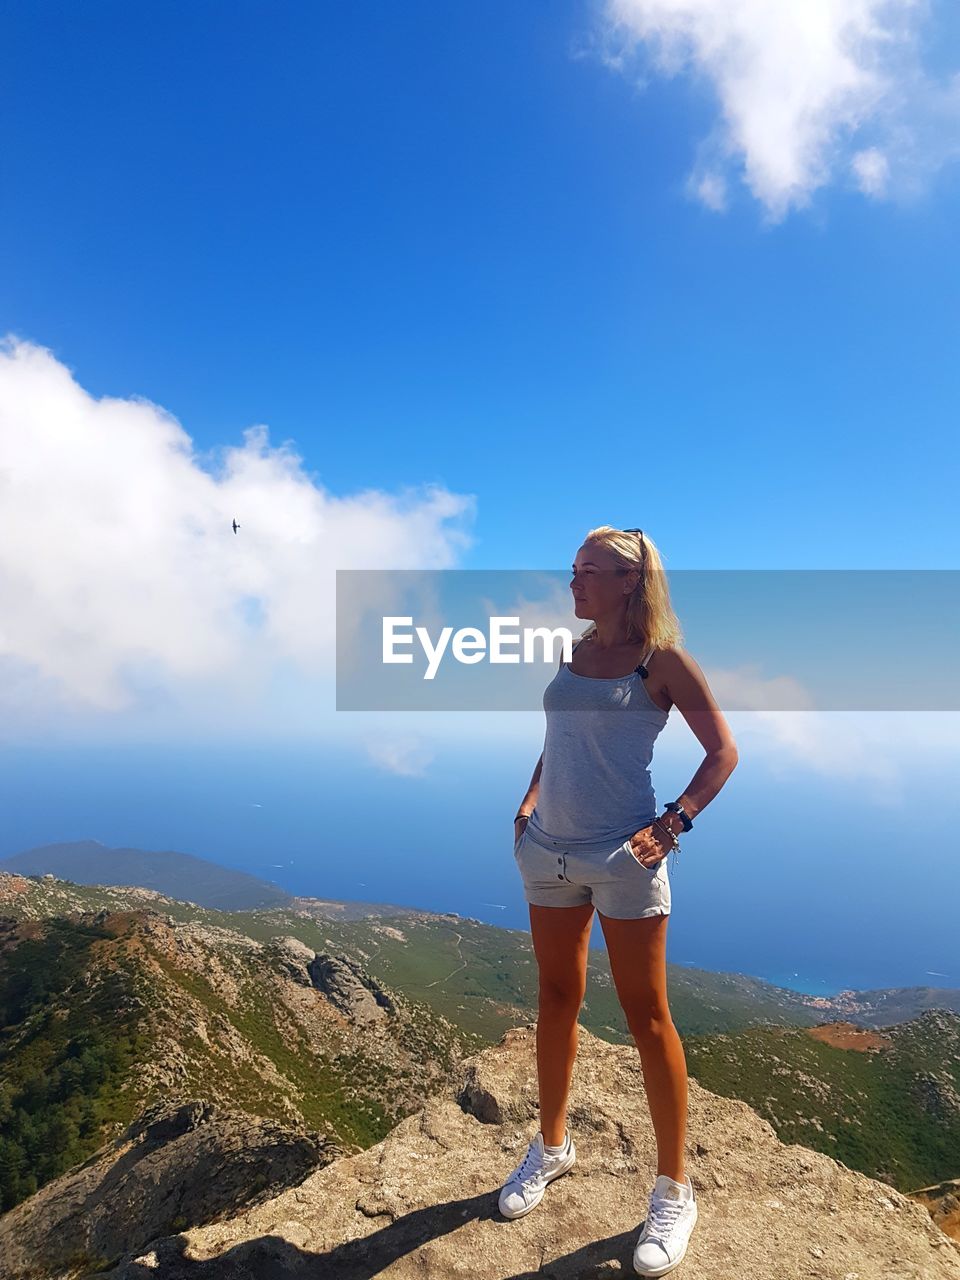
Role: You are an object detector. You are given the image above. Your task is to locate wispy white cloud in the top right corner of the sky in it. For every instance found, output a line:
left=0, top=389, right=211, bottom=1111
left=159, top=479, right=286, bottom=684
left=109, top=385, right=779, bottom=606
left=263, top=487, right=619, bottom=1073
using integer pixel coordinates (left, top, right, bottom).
left=602, top=0, right=960, bottom=220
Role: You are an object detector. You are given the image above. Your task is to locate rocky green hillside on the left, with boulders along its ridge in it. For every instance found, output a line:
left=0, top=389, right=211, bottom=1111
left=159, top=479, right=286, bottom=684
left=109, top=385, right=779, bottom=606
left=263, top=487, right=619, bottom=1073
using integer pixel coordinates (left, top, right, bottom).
left=0, top=909, right=476, bottom=1212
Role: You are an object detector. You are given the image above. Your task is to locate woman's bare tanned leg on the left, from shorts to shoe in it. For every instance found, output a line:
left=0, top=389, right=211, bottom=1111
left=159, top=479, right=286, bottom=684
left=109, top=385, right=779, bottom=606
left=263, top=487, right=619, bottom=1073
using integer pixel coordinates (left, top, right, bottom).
left=529, top=902, right=594, bottom=1147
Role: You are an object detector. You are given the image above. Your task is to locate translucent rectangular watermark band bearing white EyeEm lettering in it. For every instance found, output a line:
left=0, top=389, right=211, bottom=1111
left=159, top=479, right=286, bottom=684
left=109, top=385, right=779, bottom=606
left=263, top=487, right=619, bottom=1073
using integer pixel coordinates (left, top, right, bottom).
left=335, top=570, right=960, bottom=713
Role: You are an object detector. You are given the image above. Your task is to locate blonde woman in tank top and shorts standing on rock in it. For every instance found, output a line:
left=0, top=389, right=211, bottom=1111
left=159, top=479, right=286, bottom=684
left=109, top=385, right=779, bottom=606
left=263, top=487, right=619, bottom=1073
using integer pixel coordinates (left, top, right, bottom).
left=499, top=525, right=737, bottom=1276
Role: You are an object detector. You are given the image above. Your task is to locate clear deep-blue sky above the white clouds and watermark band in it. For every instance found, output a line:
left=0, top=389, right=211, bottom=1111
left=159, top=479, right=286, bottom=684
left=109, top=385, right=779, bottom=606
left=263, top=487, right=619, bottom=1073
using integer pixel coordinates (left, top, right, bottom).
left=0, top=3, right=960, bottom=567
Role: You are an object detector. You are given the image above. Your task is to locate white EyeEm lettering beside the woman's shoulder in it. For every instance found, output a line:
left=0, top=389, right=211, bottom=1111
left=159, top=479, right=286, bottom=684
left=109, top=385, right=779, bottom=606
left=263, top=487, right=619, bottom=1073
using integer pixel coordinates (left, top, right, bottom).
left=383, top=614, right=573, bottom=680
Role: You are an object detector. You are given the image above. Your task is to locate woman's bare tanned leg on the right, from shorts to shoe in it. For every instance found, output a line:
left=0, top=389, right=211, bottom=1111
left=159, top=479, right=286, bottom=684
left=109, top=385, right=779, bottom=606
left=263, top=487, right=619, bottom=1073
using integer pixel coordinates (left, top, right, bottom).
left=598, top=913, right=687, bottom=1183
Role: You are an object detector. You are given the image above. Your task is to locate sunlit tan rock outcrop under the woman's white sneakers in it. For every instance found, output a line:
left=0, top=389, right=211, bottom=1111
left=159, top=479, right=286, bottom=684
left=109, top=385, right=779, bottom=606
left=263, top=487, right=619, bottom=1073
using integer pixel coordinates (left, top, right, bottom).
left=71, top=1024, right=960, bottom=1280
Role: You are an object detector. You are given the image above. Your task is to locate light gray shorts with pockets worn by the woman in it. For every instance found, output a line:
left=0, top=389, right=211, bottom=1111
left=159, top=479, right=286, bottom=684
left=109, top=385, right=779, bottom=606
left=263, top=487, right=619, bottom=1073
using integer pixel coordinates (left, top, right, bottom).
left=513, top=823, right=671, bottom=920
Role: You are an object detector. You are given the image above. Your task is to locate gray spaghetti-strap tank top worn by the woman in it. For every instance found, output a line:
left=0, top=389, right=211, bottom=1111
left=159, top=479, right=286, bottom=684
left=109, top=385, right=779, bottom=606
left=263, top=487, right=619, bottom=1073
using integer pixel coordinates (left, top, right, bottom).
left=526, top=641, right=669, bottom=852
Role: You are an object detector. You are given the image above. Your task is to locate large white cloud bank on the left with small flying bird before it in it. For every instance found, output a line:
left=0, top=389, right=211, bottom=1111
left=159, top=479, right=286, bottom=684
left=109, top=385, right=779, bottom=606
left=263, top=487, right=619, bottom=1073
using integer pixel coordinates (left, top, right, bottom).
left=0, top=335, right=475, bottom=741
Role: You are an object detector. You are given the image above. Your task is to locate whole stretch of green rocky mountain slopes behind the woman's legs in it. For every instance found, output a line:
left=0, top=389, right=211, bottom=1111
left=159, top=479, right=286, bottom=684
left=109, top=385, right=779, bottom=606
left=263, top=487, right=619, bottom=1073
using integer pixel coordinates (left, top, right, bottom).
left=0, top=873, right=960, bottom=1207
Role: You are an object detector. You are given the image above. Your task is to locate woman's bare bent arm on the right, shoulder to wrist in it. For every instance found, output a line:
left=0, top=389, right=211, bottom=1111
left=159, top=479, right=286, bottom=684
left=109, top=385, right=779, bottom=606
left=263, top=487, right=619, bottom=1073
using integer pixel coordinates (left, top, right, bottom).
left=660, top=649, right=740, bottom=827
